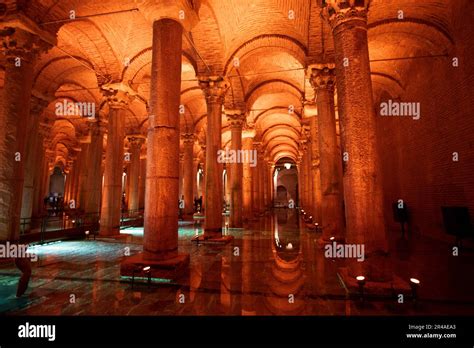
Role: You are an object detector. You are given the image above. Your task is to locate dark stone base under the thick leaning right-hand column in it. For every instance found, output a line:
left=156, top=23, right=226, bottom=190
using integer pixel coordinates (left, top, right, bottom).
left=338, top=267, right=411, bottom=297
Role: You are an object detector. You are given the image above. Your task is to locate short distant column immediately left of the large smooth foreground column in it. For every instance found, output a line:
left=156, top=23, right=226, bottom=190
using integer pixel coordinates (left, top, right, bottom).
left=128, top=134, right=145, bottom=216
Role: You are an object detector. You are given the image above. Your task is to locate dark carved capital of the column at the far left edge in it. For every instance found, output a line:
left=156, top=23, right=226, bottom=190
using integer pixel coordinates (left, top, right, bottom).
left=0, top=26, right=52, bottom=62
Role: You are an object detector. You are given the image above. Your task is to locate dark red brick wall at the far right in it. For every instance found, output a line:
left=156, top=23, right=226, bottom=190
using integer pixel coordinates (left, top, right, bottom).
left=375, top=2, right=474, bottom=240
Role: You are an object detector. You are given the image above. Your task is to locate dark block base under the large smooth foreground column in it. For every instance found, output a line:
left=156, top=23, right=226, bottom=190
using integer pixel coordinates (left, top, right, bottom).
left=120, top=253, right=189, bottom=280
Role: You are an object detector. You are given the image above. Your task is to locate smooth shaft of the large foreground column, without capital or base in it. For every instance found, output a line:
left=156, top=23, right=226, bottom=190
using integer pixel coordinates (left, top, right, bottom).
left=143, top=19, right=183, bottom=261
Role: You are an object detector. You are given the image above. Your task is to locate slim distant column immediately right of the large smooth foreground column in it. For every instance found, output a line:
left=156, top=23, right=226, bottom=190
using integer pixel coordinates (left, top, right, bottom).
left=181, top=133, right=194, bottom=220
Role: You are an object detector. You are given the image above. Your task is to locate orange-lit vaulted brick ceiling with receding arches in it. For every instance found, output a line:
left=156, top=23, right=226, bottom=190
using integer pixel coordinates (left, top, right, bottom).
left=0, top=0, right=462, bottom=167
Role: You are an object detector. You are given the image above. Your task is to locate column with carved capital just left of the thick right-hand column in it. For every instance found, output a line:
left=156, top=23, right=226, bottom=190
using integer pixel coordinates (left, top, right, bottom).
left=308, top=64, right=344, bottom=240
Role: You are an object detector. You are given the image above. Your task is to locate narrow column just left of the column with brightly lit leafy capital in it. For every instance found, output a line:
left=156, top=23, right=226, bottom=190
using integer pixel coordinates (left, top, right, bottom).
left=84, top=119, right=107, bottom=214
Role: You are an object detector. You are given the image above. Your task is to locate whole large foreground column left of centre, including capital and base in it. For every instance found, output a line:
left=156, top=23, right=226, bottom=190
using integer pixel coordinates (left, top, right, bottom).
left=120, top=4, right=198, bottom=279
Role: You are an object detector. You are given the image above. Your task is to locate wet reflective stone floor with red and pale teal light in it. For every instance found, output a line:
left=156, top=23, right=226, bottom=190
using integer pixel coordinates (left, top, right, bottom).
left=0, top=209, right=474, bottom=315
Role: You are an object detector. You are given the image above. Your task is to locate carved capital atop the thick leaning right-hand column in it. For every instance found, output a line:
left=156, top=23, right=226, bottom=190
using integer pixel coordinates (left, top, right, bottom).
left=322, top=0, right=370, bottom=30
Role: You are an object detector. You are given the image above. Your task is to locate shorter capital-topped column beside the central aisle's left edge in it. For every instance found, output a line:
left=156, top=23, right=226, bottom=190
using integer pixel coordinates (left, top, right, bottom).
left=226, top=110, right=245, bottom=228
